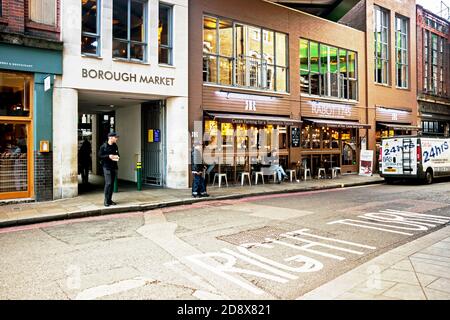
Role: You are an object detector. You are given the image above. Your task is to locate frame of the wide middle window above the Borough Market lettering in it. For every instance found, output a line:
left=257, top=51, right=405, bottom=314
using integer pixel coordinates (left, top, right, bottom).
left=111, top=0, right=149, bottom=63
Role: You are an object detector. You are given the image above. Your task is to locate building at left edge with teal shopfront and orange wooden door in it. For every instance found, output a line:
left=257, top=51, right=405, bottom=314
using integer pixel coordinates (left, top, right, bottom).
left=0, top=0, right=63, bottom=201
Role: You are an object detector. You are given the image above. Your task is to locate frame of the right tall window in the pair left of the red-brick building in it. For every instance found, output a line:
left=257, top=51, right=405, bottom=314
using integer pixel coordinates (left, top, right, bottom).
left=395, top=15, right=410, bottom=89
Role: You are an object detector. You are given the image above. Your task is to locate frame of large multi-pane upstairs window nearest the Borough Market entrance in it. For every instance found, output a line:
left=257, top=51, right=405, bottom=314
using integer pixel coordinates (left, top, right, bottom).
left=202, top=13, right=290, bottom=93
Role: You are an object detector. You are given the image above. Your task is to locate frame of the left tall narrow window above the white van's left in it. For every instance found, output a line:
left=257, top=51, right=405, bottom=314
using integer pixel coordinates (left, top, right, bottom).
left=373, top=5, right=390, bottom=85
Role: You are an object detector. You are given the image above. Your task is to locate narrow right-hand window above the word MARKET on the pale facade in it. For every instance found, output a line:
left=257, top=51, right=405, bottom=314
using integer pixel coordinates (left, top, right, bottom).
left=158, top=3, right=173, bottom=64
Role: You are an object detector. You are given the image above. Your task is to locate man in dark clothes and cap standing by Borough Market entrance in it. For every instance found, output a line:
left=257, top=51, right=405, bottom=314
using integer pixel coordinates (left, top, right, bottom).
left=99, top=132, right=119, bottom=207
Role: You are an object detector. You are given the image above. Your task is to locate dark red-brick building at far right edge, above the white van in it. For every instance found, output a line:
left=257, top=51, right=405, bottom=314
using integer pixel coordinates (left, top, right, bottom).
left=417, top=6, right=450, bottom=136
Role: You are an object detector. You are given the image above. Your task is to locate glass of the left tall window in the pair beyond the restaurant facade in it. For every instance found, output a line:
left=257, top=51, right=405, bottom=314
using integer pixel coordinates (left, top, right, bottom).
left=373, top=6, right=389, bottom=84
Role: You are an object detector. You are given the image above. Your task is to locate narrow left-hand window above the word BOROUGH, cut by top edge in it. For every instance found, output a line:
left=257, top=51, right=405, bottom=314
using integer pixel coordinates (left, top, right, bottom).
left=81, top=0, right=100, bottom=55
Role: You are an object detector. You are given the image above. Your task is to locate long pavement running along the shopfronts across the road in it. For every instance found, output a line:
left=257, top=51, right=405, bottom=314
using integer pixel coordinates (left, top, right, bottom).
left=0, top=174, right=384, bottom=227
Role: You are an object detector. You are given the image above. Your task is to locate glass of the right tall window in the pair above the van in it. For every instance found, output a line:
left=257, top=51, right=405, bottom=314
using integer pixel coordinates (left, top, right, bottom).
left=395, top=16, right=409, bottom=88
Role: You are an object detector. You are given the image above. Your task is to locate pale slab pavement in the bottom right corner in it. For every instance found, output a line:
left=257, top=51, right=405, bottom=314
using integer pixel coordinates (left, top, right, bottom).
left=298, top=226, right=450, bottom=300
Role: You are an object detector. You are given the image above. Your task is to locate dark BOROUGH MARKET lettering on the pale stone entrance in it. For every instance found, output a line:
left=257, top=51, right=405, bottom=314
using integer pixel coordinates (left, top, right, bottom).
left=81, top=68, right=175, bottom=86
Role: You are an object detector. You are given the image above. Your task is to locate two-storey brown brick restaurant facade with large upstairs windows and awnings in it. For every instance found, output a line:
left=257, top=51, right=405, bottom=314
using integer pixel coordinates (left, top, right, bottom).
left=189, top=0, right=375, bottom=178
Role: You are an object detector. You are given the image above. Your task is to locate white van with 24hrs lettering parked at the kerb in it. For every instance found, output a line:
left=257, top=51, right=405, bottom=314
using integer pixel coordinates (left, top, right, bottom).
left=380, top=136, right=450, bottom=184
